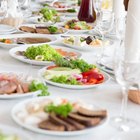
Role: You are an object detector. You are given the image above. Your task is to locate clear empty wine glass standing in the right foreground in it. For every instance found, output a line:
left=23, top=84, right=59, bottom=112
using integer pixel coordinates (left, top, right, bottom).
left=111, top=17, right=137, bottom=131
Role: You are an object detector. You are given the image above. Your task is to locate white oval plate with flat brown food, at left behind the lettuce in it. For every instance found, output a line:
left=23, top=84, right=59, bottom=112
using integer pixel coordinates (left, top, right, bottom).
left=0, top=33, right=57, bottom=49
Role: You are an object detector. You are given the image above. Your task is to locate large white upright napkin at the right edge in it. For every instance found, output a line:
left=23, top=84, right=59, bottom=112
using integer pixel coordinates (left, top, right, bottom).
left=125, top=0, right=140, bottom=62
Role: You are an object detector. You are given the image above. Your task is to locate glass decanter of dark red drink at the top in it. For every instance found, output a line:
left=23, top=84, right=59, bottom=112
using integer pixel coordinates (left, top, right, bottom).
left=78, top=0, right=96, bottom=23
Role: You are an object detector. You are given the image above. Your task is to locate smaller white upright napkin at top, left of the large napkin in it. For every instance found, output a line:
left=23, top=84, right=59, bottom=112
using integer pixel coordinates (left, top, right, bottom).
left=113, top=0, right=125, bottom=19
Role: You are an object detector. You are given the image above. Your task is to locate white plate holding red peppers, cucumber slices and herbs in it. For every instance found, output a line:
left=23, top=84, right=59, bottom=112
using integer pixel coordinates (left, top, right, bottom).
left=38, top=67, right=110, bottom=89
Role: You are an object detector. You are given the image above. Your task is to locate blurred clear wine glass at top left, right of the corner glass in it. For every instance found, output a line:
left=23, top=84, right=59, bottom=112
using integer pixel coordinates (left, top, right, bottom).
left=18, top=0, right=32, bottom=18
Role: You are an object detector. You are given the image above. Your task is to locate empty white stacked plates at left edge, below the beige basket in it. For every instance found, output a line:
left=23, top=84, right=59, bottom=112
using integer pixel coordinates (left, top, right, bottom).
left=0, top=24, right=17, bottom=35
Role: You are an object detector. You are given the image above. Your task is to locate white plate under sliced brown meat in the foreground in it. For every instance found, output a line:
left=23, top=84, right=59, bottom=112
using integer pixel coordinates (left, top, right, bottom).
left=11, top=97, right=107, bottom=136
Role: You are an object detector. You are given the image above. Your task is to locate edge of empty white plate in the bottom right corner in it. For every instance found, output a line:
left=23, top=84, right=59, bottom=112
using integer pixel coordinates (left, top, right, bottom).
left=111, top=130, right=140, bottom=140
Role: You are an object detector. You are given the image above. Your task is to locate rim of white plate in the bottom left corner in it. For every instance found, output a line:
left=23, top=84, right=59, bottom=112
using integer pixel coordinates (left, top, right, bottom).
left=0, top=124, right=32, bottom=140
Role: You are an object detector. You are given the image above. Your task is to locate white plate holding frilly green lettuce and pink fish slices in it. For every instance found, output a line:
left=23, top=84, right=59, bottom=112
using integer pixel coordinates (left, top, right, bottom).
left=9, top=45, right=81, bottom=66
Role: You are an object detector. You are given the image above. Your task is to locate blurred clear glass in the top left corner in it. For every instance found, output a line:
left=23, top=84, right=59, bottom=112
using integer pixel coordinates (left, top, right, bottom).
left=0, top=0, right=7, bottom=20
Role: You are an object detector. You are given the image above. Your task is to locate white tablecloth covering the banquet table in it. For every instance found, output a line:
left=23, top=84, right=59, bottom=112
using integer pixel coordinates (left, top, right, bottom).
left=0, top=37, right=140, bottom=140
